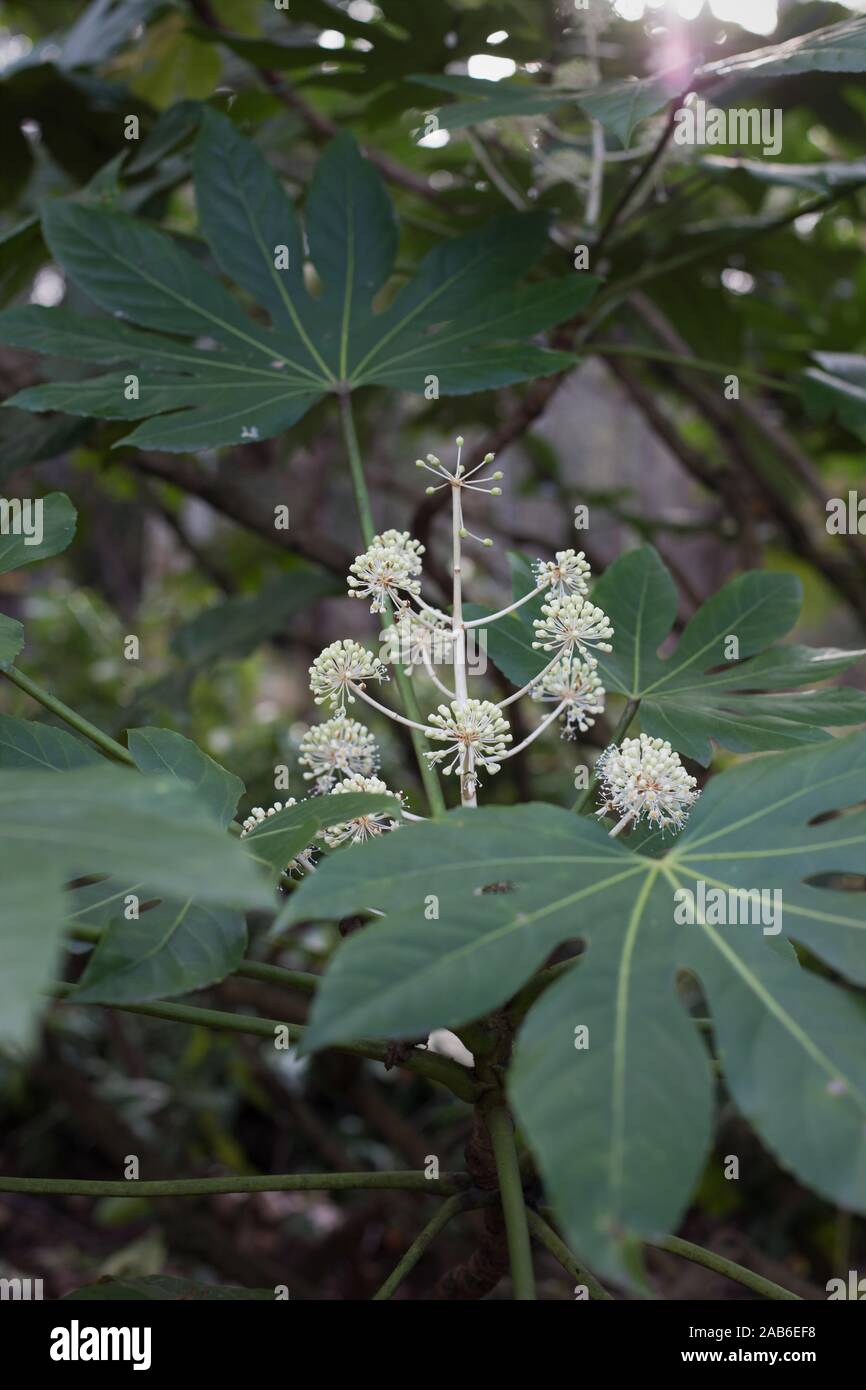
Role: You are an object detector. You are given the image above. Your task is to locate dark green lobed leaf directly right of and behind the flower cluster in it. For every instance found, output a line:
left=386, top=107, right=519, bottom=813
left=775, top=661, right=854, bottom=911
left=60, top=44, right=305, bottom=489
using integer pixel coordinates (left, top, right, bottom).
left=470, top=545, right=866, bottom=765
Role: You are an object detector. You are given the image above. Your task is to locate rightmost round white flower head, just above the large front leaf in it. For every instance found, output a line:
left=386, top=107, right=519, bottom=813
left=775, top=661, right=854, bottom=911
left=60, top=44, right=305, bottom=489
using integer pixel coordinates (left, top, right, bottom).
left=595, top=734, right=701, bottom=830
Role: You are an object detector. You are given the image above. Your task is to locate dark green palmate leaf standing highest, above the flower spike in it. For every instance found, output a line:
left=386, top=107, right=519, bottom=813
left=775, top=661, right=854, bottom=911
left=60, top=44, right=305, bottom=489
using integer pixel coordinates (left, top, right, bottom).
left=0, top=110, right=595, bottom=450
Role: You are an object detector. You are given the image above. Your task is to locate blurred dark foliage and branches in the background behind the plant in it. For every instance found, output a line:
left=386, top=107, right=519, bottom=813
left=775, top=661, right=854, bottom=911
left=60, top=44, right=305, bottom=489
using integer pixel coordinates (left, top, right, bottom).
left=0, top=0, right=866, bottom=1298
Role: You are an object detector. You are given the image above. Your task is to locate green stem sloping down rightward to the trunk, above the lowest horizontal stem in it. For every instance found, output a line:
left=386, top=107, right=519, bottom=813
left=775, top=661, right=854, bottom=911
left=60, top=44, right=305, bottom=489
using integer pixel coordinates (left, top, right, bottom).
left=47, top=984, right=477, bottom=1102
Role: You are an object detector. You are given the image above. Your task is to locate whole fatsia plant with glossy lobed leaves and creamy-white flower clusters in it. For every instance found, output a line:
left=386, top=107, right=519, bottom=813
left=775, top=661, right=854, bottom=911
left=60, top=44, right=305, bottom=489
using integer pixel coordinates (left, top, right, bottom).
left=0, top=54, right=866, bottom=1298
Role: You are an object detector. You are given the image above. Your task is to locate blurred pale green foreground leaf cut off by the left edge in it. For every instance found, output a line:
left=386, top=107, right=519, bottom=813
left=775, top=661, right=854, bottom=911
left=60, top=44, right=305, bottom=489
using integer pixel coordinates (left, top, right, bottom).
left=0, top=765, right=272, bottom=1043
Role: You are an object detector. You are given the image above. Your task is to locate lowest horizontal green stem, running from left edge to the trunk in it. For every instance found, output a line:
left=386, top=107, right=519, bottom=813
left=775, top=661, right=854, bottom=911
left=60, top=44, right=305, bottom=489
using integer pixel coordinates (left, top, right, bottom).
left=0, top=1172, right=468, bottom=1202
